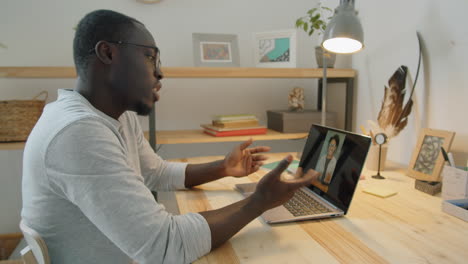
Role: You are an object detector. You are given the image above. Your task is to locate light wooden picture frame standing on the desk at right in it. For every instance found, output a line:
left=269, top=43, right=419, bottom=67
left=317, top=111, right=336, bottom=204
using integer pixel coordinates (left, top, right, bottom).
left=407, top=128, right=455, bottom=182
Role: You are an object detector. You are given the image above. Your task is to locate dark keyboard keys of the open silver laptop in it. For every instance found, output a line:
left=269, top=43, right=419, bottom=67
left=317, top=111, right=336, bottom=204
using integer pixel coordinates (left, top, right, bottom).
left=284, top=189, right=331, bottom=216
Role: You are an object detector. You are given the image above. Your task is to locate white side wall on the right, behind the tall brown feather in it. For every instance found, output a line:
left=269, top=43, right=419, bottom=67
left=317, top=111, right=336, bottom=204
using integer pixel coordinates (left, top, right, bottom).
left=348, top=0, right=468, bottom=165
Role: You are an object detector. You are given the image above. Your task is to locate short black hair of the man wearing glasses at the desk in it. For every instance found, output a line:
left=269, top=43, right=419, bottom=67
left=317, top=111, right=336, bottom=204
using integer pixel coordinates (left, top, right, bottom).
left=73, top=10, right=143, bottom=79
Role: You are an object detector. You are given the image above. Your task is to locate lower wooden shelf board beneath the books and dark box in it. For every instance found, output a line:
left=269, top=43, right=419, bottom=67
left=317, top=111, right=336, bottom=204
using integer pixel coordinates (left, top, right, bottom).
left=0, top=129, right=307, bottom=150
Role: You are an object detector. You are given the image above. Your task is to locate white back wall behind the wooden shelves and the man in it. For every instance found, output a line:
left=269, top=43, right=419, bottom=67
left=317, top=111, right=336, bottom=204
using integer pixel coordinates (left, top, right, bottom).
left=0, top=0, right=349, bottom=233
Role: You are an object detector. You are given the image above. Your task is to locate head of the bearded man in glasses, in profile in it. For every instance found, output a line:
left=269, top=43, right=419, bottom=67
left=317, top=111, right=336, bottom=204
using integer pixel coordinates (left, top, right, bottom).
left=73, top=10, right=162, bottom=115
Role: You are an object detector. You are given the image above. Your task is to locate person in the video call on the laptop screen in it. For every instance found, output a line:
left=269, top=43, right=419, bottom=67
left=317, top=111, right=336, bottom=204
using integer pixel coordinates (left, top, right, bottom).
left=312, top=131, right=345, bottom=192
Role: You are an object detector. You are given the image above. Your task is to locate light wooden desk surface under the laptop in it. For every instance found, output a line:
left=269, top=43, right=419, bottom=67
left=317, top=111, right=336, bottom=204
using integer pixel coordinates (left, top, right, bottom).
left=170, top=153, right=468, bottom=264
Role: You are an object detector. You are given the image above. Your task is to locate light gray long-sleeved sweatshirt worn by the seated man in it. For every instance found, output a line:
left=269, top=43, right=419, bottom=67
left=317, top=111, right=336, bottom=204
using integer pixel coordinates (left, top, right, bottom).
left=21, top=90, right=211, bottom=264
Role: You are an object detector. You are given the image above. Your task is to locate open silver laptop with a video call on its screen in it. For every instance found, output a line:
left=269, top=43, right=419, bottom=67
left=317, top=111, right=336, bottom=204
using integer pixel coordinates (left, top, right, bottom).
left=236, top=124, right=371, bottom=224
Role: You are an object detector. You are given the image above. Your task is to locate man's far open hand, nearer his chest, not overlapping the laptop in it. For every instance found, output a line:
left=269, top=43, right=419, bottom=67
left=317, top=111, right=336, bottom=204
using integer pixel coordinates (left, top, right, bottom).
left=223, top=139, right=270, bottom=177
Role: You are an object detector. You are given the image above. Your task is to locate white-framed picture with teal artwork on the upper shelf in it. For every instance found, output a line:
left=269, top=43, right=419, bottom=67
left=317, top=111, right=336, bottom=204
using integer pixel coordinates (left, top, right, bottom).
left=254, top=30, right=296, bottom=68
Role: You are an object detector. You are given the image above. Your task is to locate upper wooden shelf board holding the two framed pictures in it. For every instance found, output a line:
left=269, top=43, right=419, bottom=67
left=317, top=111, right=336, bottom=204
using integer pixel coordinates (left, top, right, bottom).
left=0, top=67, right=356, bottom=79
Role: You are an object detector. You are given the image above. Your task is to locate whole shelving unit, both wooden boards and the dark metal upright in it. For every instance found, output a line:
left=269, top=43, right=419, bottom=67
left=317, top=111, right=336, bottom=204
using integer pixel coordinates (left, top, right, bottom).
left=0, top=66, right=350, bottom=150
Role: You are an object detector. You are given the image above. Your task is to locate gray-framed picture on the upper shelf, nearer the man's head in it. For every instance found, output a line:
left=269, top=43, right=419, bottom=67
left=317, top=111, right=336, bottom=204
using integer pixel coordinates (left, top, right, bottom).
left=192, top=33, right=239, bottom=67
